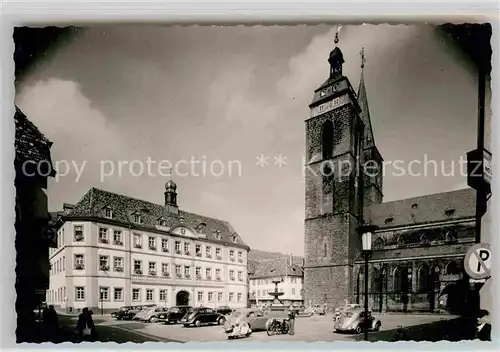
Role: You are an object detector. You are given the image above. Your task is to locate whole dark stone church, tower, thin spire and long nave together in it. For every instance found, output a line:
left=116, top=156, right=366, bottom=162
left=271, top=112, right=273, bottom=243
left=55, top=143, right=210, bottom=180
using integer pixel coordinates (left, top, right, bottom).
left=304, top=36, right=475, bottom=312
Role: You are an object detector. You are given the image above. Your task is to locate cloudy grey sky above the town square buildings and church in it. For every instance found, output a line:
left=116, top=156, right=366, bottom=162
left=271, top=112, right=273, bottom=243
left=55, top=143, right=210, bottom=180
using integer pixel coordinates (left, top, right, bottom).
left=16, top=25, right=490, bottom=255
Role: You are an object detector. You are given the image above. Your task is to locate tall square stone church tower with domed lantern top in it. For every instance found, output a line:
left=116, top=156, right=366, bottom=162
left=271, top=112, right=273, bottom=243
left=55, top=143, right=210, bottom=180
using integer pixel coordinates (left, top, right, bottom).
left=304, top=32, right=374, bottom=307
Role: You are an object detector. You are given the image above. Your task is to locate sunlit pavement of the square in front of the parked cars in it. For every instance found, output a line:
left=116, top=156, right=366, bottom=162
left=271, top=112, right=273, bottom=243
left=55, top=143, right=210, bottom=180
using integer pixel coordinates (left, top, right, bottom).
left=99, top=314, right=451, bottom=342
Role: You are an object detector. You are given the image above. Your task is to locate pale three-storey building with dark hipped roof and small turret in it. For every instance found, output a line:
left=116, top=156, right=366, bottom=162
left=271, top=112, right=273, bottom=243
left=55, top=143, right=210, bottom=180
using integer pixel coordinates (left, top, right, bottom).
left=48, top=181, right=249, bottom=311
